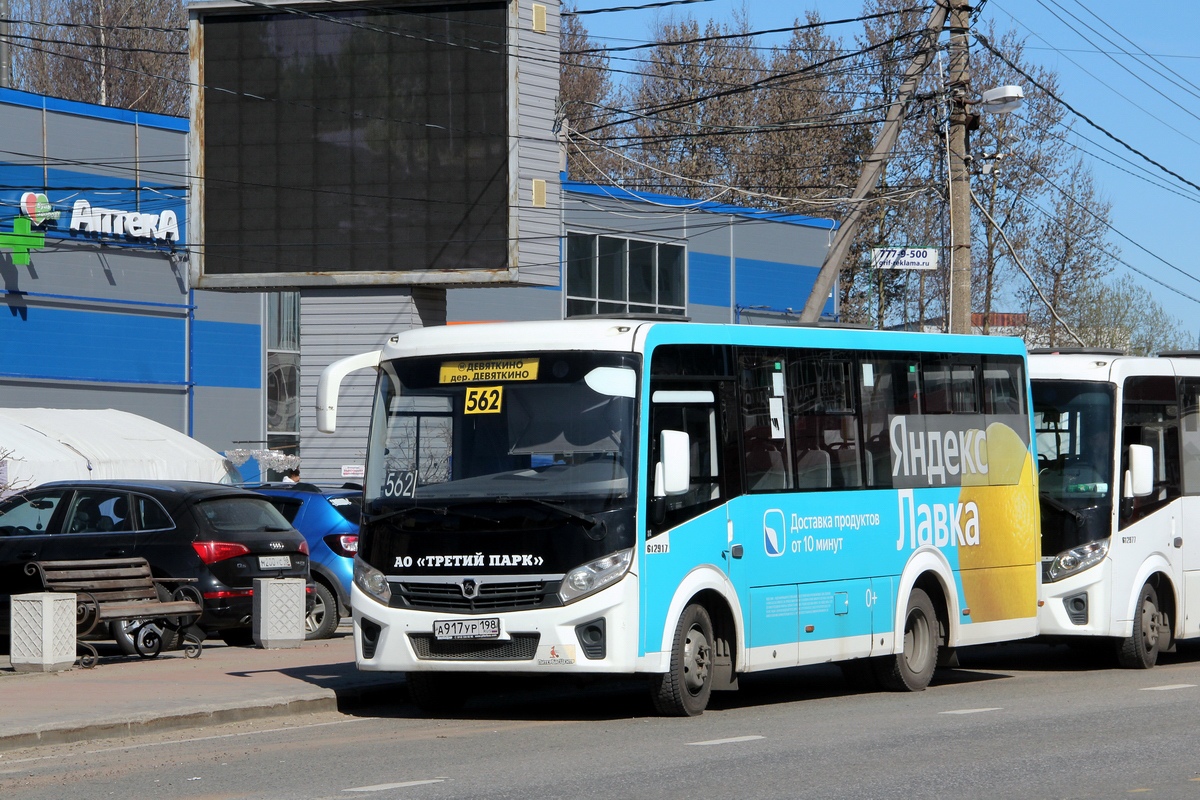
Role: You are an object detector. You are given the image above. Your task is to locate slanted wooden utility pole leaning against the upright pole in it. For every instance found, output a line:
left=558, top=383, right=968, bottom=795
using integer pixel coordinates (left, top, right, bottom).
left=800, top=0, right=945, bottom=323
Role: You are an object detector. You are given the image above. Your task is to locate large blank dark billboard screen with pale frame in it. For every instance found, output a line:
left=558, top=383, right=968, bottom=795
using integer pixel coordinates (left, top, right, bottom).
left=191, top=0, right=557, bottom=289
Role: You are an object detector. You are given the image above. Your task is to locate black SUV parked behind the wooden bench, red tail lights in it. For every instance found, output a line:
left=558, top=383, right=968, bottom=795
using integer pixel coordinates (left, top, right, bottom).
left=0, top=481, right=312, bottom=644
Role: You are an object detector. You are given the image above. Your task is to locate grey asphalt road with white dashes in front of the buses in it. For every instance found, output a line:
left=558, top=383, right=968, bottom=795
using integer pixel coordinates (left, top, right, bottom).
left=0, top=644, right=1200, bottom=800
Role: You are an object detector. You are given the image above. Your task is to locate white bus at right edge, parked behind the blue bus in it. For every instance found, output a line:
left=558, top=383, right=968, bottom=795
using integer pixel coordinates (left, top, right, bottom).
left=1030, top=350, right=1200, bottom=669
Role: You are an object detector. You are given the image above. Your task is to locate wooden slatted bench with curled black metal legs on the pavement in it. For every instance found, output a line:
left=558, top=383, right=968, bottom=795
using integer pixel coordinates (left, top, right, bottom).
left=25, top=558, right=204, bottom=669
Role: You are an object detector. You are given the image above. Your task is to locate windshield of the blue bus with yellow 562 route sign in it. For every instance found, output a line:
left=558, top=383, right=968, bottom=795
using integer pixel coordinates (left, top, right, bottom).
left=365, top=353, right=637, bottom=507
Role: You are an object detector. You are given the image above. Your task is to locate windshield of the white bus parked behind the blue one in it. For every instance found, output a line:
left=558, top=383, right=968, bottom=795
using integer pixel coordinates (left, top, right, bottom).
left=1033, top=380, right=1115, bottom=557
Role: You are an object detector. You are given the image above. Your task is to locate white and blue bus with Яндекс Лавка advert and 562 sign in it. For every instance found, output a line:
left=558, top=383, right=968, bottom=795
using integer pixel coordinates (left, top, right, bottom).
left=318, top=319, right=1040, bottom=715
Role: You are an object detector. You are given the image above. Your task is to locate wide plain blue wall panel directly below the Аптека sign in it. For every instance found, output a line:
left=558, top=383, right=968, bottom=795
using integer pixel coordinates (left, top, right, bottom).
left=0, top=306, right=187, bottom=385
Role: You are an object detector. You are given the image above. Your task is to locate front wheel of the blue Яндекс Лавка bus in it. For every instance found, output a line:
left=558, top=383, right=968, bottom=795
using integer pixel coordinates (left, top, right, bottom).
left=652, top=603, right=713, bottom=717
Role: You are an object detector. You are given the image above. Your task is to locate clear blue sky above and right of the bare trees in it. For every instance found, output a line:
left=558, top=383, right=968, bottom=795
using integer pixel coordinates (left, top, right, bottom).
left=568, top=0, right=1200, bottom=333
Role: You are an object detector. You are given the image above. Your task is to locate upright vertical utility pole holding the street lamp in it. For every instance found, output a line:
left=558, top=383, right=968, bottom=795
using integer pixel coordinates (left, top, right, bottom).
left=949, top=0, right=971, bottom=333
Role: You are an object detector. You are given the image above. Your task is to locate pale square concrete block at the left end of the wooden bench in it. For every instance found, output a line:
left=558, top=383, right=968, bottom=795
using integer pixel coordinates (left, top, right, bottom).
left=10, top=591, right=76, bottom=672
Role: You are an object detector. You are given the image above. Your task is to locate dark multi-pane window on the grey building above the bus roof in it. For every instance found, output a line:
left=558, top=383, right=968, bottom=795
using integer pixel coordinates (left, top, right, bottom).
left=566, top=234, right=688, bottom=317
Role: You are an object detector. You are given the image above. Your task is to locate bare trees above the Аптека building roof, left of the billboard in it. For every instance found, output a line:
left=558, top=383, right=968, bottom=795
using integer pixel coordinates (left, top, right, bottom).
left=10, top=0, right=188, bottom=116
